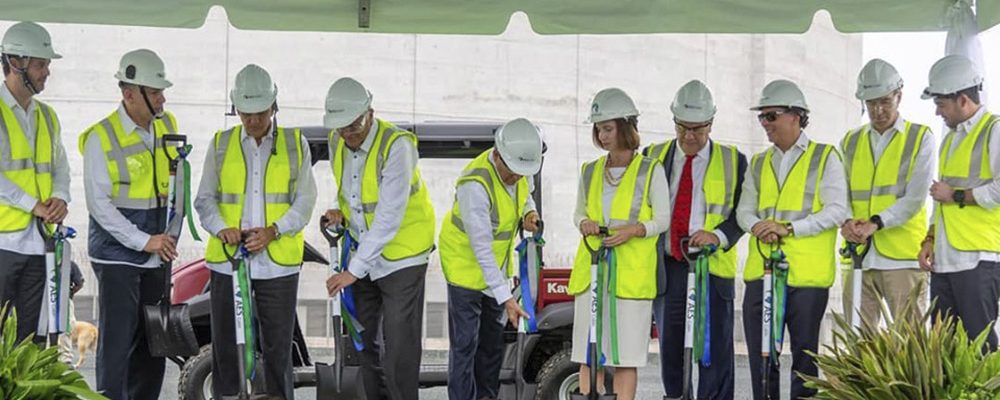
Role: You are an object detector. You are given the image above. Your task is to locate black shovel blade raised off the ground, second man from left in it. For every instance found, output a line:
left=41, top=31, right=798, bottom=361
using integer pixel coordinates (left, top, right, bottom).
left=143, top=304, right=199, bottom=357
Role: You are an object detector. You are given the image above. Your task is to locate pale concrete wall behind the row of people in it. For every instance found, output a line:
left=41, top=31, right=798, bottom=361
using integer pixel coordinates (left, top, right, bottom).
left=0, top=12, right=862, bottom=344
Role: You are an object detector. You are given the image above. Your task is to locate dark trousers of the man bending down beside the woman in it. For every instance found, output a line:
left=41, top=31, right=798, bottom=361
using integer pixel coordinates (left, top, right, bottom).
left=448, top=285, right=504, bottom=400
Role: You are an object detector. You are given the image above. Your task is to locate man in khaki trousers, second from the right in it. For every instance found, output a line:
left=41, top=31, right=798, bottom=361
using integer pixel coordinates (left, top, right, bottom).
left=840, top=58, right=936, bottom=325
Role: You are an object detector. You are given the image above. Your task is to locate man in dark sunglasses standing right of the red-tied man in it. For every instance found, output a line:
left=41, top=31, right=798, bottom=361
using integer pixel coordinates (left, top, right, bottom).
left=736, top=80, right=850, bottom=399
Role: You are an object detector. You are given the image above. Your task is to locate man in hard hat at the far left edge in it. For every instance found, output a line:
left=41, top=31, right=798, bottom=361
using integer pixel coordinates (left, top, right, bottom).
left=0, top=22, right=70, bottom=342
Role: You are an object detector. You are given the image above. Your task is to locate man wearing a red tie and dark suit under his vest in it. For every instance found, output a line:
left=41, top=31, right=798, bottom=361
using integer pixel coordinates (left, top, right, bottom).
left=643, top=80, right=747, bottom=399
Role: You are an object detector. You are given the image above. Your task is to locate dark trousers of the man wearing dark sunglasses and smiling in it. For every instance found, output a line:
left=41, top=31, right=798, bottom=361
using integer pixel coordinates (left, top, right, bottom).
left=743, top=279, right=830, bottom=400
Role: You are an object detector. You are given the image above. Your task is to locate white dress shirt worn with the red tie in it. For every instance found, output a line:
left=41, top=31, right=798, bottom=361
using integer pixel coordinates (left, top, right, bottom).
left=664, top=141, right=729, bottom=255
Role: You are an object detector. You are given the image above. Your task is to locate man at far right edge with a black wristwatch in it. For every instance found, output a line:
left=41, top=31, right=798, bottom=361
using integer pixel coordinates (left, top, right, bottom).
left=918, top=55, right=1000, bottom=350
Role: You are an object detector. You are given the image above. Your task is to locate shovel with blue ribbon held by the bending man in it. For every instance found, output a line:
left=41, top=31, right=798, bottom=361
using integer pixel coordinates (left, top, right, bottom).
left=514, top=220, right=545, bottom=400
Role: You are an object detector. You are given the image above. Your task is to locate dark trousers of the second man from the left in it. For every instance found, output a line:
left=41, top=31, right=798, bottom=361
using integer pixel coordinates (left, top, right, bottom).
left=91, top=263, right=165, bottom=400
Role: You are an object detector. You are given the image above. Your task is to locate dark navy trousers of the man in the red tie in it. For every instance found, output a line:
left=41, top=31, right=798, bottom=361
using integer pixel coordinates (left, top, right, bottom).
left=653, top=257, right=734, bottom=400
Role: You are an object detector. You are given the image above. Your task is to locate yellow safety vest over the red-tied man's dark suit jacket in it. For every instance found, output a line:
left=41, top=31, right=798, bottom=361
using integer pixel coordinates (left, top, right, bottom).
left=643, top=139, right=739, bottom=279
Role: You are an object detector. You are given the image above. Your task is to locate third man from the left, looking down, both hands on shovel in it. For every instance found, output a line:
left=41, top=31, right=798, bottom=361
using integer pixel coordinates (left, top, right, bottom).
left=195, top=64, right=316, bottom=400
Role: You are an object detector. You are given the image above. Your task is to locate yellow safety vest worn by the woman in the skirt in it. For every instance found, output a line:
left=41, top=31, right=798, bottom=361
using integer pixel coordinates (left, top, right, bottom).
left=569, top=154, right=659, bottom=300
